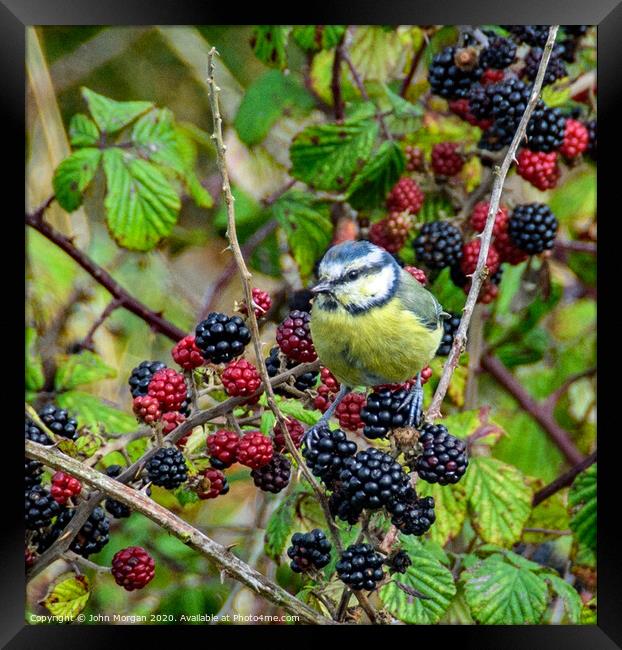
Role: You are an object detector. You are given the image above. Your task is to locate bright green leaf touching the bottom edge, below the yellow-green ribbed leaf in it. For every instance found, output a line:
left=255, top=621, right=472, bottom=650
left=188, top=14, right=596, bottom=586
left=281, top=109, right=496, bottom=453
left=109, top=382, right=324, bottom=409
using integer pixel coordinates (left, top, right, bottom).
left=462, top=555, right=548, bottom=625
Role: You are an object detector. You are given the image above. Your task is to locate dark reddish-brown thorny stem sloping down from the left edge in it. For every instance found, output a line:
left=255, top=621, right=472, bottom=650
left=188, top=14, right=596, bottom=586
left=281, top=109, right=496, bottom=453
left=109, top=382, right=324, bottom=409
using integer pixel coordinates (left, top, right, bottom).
left=26, top=208, right=186, bottom=341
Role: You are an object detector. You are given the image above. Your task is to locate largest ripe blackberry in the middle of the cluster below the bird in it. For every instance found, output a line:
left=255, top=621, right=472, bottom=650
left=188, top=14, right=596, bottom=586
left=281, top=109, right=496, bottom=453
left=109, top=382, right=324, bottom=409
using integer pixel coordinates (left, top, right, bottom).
left=339, top=447, right=410, bottom=510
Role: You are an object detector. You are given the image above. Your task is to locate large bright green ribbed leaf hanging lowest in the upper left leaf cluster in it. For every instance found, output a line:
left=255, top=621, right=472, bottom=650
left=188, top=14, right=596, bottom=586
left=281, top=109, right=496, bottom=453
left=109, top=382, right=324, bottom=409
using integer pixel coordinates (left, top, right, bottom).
left=104, top=149, right=181, bottom=251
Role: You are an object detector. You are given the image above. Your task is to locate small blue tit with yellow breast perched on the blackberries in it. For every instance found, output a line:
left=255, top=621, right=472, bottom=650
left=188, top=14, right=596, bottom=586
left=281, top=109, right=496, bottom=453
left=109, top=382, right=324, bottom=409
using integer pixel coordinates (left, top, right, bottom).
left=305, top=241, right=450, bottom=447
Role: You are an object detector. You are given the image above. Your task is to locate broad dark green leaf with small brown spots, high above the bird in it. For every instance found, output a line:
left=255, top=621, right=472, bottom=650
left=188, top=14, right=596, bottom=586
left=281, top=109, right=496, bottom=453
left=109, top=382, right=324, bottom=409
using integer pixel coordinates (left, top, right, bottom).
left=290, top=120, right=378, bottom=192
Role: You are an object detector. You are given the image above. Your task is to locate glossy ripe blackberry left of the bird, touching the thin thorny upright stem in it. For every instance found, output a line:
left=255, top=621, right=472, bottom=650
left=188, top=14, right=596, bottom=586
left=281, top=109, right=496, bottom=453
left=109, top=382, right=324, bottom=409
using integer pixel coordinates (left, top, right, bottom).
left=194, top=312, right=251, bottom=363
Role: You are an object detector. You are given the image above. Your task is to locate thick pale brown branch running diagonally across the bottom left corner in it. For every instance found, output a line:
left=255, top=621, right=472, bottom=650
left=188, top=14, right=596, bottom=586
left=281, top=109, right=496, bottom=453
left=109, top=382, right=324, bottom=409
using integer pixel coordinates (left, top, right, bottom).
left=26, top=440, right=332, bottom=625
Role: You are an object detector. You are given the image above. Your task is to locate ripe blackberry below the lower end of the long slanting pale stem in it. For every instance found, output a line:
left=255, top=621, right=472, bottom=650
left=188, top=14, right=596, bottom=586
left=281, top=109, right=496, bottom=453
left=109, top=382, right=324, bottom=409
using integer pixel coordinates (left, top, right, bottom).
left=414, top=424, right=469, bottom=485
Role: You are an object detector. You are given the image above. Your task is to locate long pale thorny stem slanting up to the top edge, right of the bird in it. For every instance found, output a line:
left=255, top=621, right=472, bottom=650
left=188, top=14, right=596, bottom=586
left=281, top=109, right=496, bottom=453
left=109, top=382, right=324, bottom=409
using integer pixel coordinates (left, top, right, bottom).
left=427, top=25, right=558, bottom=421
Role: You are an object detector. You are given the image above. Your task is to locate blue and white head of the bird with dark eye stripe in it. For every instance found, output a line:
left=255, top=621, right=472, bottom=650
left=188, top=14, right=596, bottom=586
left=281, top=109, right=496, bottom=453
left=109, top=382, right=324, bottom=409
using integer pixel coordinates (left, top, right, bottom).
left=311, top=241, right=400, bottom=314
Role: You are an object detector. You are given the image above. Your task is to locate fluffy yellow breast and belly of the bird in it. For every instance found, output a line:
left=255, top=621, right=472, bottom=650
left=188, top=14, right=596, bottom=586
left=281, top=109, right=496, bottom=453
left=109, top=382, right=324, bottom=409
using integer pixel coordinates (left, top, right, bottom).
left=311, top=297, right=443, bottom=387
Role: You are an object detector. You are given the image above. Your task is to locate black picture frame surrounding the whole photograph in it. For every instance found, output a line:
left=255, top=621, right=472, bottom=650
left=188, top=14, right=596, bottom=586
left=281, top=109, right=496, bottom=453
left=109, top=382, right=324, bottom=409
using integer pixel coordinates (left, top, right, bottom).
left=6, top=0, right=622, bottom=650
